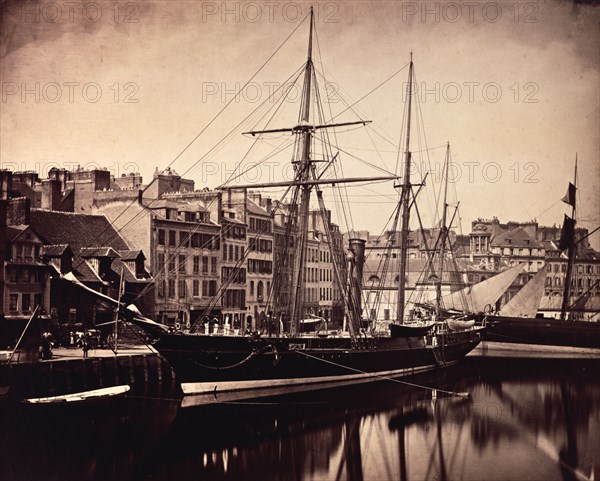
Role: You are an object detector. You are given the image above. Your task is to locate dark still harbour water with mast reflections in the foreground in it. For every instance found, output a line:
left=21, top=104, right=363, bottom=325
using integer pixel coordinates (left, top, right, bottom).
left=0, top=358, right=600, bottom=481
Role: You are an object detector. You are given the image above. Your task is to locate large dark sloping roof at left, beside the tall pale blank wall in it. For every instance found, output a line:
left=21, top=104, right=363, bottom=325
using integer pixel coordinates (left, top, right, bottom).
left=29, top=209, right=129, bottom=254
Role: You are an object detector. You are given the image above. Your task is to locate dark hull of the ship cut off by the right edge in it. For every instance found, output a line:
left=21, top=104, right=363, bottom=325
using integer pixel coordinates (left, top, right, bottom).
left=486, top=316, right=600, bottom=349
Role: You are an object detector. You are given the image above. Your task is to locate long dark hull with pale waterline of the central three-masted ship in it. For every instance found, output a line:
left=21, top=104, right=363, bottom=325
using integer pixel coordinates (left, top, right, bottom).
left=154, top=329, right=484, bottom=402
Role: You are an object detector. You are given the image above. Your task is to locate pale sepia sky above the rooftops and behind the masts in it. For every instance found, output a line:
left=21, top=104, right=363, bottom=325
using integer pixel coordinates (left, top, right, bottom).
left=0, top=0, right=600, bottom=249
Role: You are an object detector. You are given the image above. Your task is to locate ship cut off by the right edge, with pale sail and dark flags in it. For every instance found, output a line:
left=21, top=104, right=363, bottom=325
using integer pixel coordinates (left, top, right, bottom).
left=486, top=159, right=600, bottom=349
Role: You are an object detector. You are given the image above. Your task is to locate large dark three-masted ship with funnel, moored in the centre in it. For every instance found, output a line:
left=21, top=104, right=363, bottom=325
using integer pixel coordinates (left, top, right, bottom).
left=129, top=10, right=484, bottom=402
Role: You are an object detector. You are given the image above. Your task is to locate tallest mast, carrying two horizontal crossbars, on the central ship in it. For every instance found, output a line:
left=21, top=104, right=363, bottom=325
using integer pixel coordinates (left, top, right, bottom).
left=290, top=7, right=314, bottom=334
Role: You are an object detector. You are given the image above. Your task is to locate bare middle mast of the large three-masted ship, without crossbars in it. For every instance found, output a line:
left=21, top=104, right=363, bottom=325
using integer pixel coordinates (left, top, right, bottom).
left=396, top=52, right=413, bottom=324
